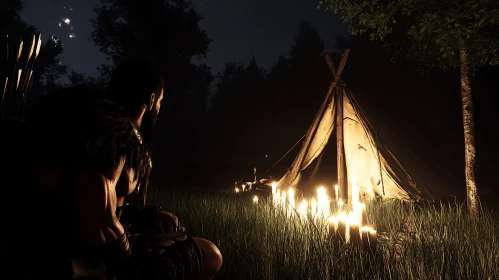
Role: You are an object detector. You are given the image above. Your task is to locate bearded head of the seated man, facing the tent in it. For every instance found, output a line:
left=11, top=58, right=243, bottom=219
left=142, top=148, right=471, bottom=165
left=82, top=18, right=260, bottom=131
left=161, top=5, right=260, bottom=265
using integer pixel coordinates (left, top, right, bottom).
left=107, top=59, right=164, bottom=142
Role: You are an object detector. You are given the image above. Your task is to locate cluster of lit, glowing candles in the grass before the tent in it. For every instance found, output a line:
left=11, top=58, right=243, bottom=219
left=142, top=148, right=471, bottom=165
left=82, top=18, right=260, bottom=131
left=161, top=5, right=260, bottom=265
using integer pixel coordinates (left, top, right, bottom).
left=274, top=178, right=377, bottom=252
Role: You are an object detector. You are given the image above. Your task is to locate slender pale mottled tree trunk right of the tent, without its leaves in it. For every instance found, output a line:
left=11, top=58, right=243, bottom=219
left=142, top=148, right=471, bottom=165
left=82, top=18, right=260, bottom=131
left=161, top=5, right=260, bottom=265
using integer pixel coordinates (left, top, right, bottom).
left=459, top=40, right=479, bottom=218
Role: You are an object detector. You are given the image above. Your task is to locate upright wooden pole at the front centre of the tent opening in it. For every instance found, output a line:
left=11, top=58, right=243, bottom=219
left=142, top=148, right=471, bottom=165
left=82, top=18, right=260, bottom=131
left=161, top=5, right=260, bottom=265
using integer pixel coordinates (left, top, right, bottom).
left=336, top=85, right=352, bottom=202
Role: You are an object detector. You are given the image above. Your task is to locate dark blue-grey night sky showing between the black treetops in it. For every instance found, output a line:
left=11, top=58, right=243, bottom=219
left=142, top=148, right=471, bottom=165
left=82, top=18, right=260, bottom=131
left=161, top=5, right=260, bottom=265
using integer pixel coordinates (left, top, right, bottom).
left=22, top=0, right=347, bottom=76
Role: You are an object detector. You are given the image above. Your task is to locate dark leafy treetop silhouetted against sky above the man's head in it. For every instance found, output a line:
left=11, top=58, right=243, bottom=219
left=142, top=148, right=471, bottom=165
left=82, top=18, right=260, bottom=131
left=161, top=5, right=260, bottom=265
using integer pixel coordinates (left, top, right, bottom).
left=91, top=0, right=211, bottom=92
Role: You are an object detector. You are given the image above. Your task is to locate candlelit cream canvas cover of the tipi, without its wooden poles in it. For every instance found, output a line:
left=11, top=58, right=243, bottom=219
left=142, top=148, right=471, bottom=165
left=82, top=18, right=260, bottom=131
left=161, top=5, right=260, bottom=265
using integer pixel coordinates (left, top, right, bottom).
left=277, top=84, right=438, bottom=201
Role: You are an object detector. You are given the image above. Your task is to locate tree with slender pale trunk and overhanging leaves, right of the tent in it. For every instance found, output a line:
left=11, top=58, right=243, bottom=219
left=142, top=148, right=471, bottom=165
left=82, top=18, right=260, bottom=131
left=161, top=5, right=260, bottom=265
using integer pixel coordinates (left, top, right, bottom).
left=318, top=0, right=499, bottom=217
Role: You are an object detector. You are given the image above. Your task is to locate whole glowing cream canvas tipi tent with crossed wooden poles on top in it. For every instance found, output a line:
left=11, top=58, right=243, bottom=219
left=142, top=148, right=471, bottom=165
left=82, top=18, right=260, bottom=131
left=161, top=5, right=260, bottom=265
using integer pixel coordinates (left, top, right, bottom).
left=277, top=50, right=429, bottom=201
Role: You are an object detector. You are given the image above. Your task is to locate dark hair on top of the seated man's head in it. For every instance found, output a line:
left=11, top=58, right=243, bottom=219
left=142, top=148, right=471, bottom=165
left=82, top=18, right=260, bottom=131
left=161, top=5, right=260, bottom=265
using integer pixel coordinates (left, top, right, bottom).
left=106, top=58, right=164, bottom=115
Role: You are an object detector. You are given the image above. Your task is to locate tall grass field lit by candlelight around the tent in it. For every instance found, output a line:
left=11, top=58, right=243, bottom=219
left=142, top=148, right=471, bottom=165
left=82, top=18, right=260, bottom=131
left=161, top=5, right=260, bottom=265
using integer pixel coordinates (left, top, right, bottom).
left=149, top=186, right=499, bottom=279
